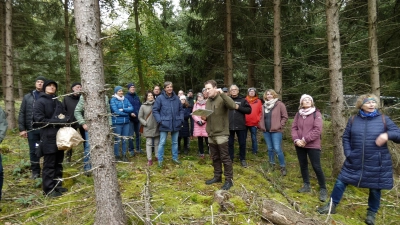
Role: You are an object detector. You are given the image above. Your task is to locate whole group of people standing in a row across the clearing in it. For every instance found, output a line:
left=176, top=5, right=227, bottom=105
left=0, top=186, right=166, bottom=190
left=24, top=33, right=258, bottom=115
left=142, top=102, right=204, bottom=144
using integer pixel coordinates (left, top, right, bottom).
left=13, top=76, right=400, bottom=224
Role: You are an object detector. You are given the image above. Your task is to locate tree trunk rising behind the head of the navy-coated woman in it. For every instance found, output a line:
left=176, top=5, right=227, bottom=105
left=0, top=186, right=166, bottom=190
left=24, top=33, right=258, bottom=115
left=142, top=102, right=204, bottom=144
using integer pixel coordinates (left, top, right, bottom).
left=368, top=0, right=381, bottom=97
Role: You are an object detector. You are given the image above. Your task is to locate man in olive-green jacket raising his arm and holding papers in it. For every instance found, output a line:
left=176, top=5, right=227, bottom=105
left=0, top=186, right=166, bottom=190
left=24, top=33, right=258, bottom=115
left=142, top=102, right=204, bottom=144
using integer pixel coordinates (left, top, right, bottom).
left=202, top=80, right=238, bottom=190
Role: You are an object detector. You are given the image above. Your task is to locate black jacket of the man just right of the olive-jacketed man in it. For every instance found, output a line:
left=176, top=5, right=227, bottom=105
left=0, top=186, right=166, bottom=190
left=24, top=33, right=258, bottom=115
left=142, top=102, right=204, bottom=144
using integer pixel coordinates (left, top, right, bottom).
left=229, top=95, right=251, bottom=130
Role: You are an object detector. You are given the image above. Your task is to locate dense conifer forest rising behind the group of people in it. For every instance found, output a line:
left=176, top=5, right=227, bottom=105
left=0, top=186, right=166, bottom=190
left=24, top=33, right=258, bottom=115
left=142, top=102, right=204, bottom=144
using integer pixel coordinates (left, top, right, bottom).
left=0, top=0, right=400, bottom=224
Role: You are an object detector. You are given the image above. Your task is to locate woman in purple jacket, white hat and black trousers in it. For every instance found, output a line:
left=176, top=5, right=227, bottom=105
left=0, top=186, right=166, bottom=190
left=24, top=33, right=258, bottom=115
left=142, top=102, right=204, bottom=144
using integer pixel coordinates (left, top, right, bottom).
left=292, top=94, right=328, bottom=202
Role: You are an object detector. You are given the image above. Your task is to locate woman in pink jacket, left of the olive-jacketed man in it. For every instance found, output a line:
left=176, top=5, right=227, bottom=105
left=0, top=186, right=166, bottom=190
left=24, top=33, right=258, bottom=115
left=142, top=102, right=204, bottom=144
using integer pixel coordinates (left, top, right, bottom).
left=192, top=93, right=208, bottom=158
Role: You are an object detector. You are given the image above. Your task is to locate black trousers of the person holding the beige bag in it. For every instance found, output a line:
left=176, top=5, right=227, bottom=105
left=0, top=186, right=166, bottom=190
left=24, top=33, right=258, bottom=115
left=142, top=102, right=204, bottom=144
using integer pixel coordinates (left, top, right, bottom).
left=42, top=151, right=64, bottom=194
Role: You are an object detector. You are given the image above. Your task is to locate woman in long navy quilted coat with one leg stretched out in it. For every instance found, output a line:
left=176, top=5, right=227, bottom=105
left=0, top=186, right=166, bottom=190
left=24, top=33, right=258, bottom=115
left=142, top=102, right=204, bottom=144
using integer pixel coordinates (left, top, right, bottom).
left=318, top=94, right=400, bottom=225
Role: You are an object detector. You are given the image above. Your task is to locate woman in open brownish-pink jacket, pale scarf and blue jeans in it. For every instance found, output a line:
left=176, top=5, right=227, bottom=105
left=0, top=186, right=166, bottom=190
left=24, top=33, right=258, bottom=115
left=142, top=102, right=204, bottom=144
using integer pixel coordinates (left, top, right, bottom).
left=259, top=89, right=288, bottom=176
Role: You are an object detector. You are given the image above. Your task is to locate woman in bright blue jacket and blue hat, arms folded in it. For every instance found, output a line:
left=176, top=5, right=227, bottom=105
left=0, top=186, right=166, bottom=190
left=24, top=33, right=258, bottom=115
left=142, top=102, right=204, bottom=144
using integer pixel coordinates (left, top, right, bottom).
left=110, top=86, right=133, bottom=162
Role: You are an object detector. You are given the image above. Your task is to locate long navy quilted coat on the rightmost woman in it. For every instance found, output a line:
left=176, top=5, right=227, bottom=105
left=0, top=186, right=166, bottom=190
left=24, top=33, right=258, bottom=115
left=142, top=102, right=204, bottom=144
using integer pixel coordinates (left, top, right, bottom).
left=338, top=115, right=400, bottom=189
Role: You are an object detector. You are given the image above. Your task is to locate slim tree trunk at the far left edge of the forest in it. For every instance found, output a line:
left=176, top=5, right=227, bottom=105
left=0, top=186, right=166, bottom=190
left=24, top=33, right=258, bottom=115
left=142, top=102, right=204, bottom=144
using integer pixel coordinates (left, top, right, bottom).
left=4, top=0, right=16, bottom=129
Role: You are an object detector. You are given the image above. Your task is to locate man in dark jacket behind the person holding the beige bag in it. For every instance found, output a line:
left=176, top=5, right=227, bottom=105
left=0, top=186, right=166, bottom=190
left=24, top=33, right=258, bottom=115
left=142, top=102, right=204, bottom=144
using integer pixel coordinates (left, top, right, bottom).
left=18, top=76, right=46, bottom=179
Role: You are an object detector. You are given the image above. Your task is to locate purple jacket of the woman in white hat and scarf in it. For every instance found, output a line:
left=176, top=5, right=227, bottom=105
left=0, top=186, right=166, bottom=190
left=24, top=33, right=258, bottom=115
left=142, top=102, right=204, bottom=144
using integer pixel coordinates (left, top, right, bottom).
left=292, top=110, right=322, bottom=149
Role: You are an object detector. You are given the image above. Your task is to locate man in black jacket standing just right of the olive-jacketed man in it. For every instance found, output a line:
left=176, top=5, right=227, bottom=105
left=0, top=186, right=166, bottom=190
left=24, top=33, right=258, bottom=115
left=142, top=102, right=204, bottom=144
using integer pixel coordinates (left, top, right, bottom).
left=229, top=84, right=251, bottom=167
